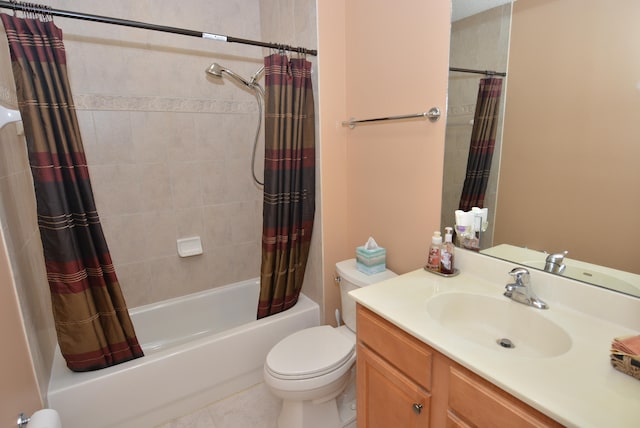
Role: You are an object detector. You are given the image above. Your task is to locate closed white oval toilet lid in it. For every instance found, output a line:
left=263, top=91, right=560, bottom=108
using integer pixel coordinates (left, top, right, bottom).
left=266, top=325, right=355, bottom=379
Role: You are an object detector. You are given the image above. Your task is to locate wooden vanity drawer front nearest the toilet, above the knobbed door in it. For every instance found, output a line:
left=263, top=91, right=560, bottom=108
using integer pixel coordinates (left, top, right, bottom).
left=356, top=305, right=432, bottom=390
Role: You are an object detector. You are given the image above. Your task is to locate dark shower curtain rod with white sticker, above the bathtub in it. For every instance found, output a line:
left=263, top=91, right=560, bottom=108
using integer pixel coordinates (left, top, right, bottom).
left=0, top=0, right=318, bottom=56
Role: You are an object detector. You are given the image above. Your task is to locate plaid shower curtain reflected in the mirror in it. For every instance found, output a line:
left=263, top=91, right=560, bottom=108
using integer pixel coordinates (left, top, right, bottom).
left=458, top=77, right=502, bottom=211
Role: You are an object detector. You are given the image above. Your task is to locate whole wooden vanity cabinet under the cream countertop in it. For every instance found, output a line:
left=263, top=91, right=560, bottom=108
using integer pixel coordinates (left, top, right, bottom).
left=357, top=305, right=561, bottom=428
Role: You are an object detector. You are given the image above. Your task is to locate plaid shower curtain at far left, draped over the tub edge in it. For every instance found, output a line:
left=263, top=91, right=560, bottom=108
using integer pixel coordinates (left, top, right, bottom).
left=0, top=14, right=143, bottom=371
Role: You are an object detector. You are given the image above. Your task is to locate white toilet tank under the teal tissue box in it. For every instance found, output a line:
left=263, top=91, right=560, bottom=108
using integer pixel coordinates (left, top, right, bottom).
left=336, top=259, right=397, bottom=331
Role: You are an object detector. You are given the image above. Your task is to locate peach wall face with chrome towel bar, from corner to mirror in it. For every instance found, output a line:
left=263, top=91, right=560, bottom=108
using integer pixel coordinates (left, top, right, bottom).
left=345, top=0, right=451, bottom=273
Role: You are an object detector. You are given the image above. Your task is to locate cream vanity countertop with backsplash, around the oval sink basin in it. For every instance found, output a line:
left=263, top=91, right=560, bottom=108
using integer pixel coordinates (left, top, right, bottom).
left=351, top=251, right=640, bottom=428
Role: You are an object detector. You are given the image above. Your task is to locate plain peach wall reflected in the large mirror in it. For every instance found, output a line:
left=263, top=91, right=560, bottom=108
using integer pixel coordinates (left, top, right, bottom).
left=495, top=0, right=640, bottom=273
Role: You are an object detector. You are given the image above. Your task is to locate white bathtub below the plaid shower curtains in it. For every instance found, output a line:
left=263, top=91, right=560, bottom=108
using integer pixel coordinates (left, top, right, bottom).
left=47, top=279, right=320, bottom=428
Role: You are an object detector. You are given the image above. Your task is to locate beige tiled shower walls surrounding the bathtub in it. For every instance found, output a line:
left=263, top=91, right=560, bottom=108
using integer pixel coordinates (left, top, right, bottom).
left=0, top=0, right=322, bottom=404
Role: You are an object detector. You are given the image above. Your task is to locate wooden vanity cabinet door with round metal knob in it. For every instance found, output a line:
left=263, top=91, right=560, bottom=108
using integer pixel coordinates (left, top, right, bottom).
left=356, top=344, right=430, bottom=428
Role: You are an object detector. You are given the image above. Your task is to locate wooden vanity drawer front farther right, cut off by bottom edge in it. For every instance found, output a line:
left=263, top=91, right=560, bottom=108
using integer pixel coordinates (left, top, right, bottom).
left=449, top=366, right=561, bottom=428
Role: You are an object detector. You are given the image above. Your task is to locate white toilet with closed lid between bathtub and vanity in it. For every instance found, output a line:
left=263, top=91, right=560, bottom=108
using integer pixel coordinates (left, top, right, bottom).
left=264, top=259, right=396, bottom=428
